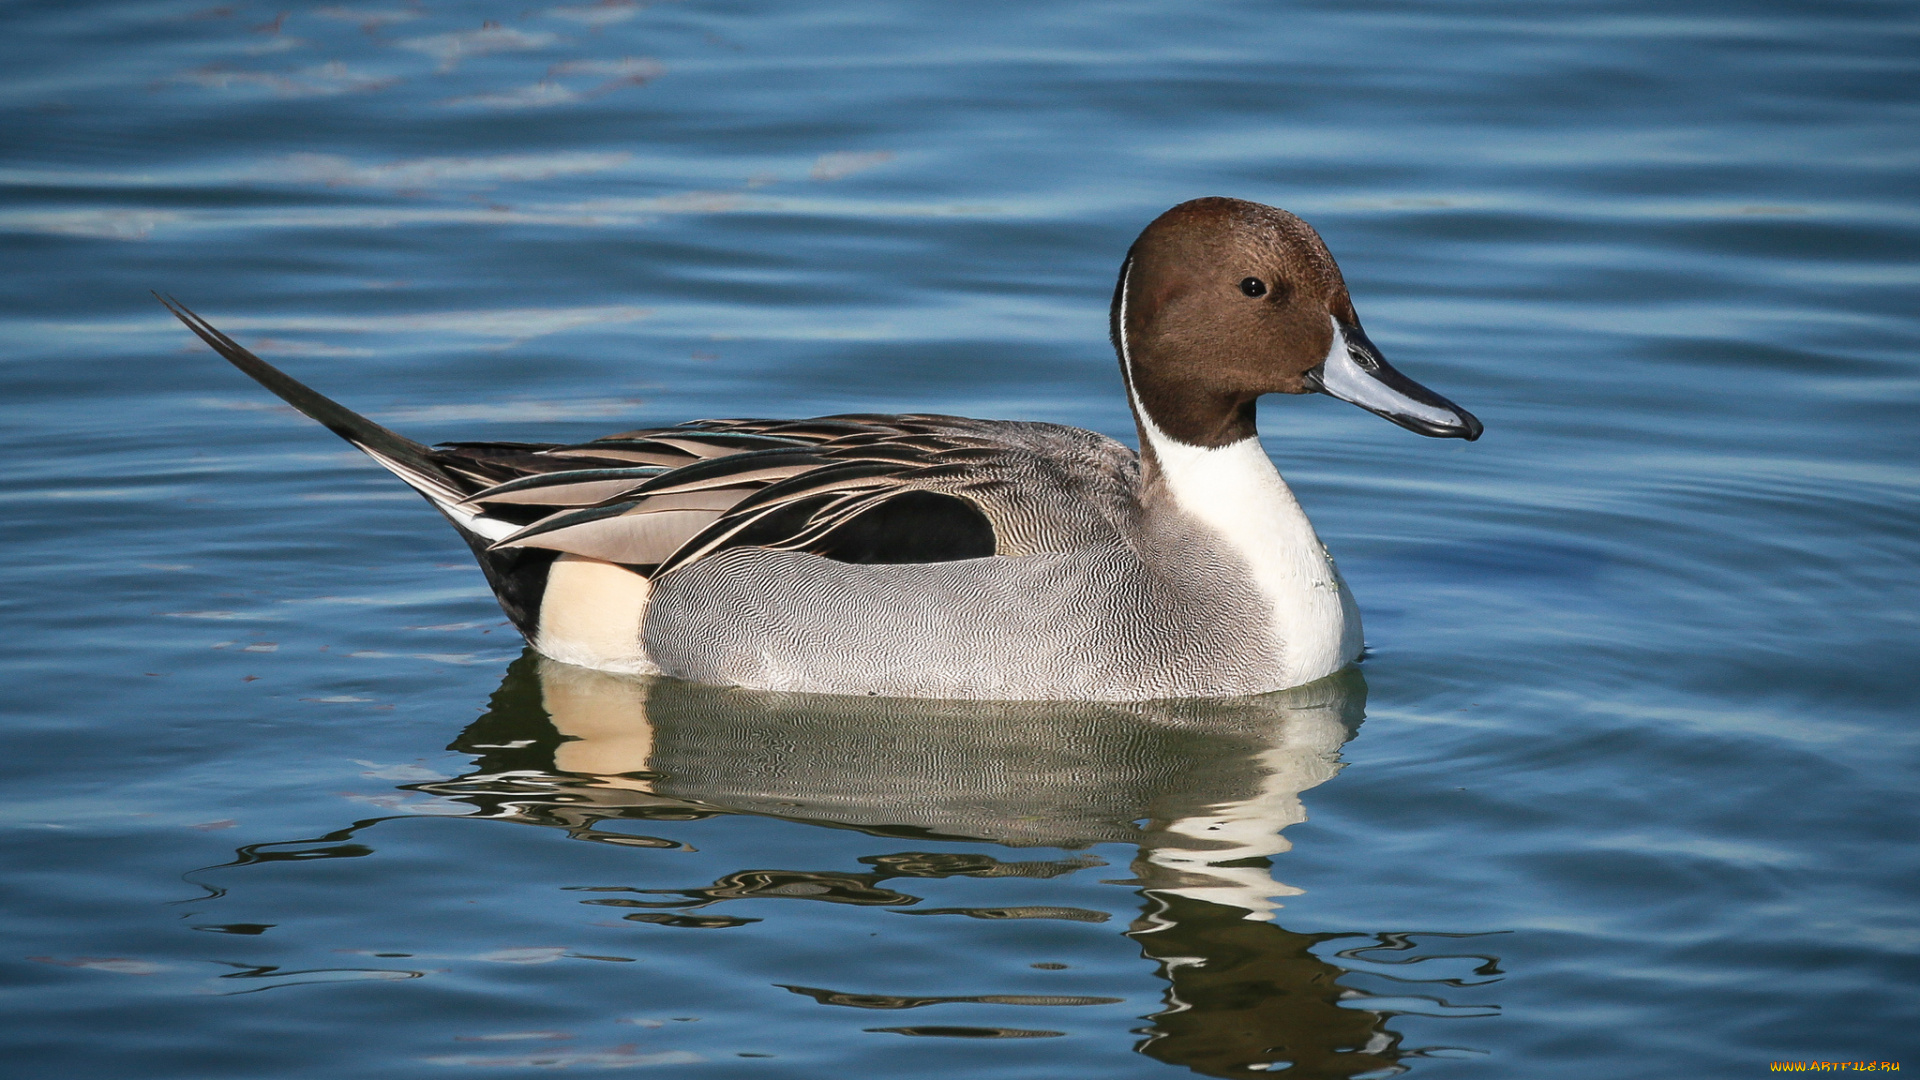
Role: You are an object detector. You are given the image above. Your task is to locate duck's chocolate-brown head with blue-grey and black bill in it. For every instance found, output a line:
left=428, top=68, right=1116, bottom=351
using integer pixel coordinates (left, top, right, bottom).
left=1112, top=198, right=1480, bottom=446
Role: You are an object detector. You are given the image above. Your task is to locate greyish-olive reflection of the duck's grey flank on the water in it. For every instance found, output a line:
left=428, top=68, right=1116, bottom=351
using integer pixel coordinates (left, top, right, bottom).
left=629, top=665, right=1363, bottom=847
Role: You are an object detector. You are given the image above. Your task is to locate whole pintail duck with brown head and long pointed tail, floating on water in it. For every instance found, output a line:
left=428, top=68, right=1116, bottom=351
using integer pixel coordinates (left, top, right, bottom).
left=167, top=198, right=1480, bottom=701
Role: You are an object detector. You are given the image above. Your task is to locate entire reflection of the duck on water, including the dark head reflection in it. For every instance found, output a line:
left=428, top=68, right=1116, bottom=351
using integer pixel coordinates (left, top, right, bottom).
left=389, top=653, right=1492, bottom=1076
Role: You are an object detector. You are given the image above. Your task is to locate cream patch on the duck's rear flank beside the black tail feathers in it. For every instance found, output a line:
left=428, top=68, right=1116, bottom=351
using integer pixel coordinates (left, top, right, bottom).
left=534, top=553, right=660, bottom=675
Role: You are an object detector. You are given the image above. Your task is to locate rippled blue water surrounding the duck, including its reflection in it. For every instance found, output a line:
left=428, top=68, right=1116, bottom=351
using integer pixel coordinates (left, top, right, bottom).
left=0, top=0, right=1920, bottom=1080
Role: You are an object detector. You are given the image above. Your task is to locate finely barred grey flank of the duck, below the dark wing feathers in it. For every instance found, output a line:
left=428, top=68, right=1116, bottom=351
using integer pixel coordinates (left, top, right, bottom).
left=643, top=546, right=1281, bottom=701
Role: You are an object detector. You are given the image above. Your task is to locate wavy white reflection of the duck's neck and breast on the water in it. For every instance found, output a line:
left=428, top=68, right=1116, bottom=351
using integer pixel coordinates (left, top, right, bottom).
left=1146, top=687, right=1348, bottom=919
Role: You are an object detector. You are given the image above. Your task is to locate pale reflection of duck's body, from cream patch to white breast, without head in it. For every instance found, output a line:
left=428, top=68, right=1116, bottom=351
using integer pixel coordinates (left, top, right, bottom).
left=518, top=661, right=1365, bottom=917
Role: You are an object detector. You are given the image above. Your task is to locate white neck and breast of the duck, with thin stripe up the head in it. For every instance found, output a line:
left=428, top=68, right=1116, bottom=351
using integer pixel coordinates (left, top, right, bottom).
left=1116, top=257, right=1361, bottom=686
